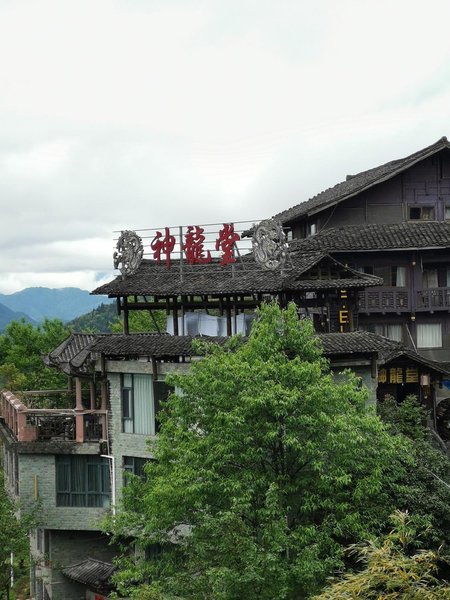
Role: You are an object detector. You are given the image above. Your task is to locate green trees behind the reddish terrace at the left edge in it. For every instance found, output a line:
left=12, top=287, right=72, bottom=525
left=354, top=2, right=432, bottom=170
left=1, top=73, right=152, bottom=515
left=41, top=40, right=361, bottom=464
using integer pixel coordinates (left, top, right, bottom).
left=0, top=319, right=70, bottom=390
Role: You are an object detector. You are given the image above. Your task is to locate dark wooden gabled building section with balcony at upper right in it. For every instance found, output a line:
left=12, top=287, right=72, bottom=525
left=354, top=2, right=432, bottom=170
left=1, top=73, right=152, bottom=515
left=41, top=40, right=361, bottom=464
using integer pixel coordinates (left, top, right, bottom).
left=277, top=138, right=450, bottom=361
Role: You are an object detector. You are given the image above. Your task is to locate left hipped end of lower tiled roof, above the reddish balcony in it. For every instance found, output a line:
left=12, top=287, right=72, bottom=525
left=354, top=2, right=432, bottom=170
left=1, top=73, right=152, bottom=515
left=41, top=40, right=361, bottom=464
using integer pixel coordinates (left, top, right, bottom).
left=43, top=333, right=99, bottom=375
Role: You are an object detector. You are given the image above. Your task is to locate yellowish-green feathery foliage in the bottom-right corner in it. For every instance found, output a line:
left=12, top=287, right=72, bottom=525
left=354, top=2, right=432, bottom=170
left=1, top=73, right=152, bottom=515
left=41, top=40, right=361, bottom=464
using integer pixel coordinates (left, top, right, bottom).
left=315, top=512, right=450, bottom=600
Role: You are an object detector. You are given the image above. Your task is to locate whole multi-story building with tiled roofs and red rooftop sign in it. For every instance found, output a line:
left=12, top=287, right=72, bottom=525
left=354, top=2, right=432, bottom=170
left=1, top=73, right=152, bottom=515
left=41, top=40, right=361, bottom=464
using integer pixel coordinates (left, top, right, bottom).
left=0, top=140, right=450, bottom=600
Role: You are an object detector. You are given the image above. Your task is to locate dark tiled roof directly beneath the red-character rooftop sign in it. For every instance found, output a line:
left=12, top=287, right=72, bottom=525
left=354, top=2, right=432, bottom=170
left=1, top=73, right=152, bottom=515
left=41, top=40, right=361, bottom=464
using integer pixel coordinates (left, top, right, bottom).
left=92, top=246, right=381, bottom=297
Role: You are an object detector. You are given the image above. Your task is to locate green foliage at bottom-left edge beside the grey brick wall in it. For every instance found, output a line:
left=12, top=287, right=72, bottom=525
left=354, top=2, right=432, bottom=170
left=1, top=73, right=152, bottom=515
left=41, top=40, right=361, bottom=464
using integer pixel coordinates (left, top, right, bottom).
left=0, top=469, right=29, bottom=598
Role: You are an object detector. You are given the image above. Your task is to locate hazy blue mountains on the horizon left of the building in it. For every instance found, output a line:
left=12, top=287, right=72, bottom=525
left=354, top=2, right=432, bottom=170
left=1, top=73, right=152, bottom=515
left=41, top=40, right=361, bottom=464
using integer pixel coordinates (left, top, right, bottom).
left=0, top=287, right=110, bottom=330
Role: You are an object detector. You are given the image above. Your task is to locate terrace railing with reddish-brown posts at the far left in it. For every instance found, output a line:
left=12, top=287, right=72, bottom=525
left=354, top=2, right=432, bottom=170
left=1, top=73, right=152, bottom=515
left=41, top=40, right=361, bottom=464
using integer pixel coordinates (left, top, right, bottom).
left=0, top=390, right=107, bottom=442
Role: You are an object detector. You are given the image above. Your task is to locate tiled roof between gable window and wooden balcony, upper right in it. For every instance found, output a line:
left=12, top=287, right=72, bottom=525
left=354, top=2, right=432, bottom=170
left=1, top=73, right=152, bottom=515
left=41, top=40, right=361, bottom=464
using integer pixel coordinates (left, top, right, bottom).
left=294, top=221, right=450, bottom=252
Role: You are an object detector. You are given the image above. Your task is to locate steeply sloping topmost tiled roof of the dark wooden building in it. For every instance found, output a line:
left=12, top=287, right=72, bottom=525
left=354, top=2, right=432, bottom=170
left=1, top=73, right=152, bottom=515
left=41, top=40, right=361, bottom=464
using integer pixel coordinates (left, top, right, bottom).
left=274, top=137, right=450, bottom=224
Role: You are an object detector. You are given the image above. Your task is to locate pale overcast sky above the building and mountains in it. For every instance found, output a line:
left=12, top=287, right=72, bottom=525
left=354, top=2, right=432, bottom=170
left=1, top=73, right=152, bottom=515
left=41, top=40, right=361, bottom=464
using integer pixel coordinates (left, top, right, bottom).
left=0, top=0, right=450, bottom=293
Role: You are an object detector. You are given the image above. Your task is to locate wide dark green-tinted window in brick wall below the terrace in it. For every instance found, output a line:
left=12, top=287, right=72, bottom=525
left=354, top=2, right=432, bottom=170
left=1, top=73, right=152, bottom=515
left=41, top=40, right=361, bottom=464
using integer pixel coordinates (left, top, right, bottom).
left=56, top=455, right=110, bottom=508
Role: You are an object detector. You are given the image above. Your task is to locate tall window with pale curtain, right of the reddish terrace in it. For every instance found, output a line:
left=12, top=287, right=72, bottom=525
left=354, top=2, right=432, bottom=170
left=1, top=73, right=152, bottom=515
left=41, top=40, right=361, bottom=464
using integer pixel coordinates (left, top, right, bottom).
left=122, top=373, right=172, bottom=435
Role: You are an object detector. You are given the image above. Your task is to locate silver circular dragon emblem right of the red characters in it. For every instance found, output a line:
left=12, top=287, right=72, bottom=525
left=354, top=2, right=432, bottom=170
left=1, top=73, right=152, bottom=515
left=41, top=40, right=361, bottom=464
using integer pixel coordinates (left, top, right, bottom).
left=252, top=219, right=288, bottom=271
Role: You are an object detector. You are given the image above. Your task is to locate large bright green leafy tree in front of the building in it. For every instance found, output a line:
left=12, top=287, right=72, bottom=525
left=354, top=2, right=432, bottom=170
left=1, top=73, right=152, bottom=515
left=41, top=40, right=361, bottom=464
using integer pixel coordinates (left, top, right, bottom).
left=112, top=304, right=409, bottom=600
